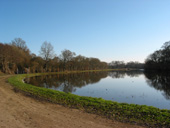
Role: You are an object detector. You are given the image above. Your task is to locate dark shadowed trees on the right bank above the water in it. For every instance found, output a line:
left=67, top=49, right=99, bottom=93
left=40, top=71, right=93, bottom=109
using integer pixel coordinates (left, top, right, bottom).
left=145, top=41, right=170, bottom=71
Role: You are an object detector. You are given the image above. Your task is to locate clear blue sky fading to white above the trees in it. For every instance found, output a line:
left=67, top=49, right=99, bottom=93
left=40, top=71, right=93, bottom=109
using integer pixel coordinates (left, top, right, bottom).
left=0, top=0, right=170, bottom=62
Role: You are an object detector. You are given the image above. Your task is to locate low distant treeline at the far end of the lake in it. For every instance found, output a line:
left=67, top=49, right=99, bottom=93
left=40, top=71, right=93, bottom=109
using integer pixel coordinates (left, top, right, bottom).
left=109, top=61, right=144, bottom=69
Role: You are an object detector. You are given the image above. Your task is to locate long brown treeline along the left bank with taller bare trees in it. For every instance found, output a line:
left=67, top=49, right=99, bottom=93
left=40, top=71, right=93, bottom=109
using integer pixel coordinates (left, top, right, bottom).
left=0, top=38, right=108, bottom=74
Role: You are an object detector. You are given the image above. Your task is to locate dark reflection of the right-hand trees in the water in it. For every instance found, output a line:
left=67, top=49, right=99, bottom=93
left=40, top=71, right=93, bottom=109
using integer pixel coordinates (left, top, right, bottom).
left=145, top=72, right=170, bottom=100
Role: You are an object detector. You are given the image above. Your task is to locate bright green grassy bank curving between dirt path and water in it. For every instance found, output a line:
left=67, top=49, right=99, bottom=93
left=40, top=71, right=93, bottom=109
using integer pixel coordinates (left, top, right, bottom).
left=8, top=71, right=170, bottom=127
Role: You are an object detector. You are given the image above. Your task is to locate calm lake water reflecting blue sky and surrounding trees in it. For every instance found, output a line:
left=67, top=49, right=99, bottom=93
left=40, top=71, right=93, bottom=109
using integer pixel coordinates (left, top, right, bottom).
left=26, top=71, right=170, bottom=109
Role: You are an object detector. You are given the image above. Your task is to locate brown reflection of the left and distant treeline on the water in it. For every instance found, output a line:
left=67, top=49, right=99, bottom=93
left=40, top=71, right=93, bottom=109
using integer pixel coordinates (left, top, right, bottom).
left=25, top=71, right=143, bottom=93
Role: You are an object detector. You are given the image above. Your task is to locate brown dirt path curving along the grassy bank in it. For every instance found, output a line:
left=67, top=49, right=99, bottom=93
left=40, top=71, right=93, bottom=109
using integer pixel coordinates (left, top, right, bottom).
left=0, top=76, right=145, bottom=128
